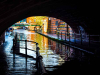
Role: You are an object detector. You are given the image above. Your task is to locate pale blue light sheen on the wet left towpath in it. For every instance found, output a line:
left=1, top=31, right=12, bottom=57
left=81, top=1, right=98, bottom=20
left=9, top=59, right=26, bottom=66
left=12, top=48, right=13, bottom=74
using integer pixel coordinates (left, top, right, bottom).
left=2, top=32, right=36, bottom=75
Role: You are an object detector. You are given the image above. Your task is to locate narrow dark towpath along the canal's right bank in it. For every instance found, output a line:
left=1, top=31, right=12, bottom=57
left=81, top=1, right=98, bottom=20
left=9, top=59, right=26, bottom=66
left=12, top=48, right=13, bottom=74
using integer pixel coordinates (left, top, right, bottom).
left=38, top=32, right=100, bottom=54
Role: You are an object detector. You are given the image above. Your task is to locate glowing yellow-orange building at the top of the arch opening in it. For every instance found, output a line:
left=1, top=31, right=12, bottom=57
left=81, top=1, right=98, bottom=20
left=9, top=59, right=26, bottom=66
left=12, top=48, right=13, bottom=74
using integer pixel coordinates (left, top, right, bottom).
left=26, top=16, right=48, bottom=32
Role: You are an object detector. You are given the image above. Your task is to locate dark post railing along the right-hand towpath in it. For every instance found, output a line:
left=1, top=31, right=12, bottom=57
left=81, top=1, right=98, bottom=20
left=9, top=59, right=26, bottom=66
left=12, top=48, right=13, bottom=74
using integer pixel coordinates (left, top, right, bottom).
left=57, top=32, right=100, bottom=46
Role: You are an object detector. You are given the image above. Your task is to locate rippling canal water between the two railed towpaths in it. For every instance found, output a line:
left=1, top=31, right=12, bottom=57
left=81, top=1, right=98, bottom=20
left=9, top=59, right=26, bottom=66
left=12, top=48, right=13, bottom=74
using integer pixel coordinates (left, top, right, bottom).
left=14, top=29, right=93, bottom=71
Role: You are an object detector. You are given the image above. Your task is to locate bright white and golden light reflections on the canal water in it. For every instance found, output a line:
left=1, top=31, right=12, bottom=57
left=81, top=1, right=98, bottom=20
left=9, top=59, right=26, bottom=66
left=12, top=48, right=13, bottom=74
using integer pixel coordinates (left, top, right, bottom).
left=13, top=30, right=64, bottom=71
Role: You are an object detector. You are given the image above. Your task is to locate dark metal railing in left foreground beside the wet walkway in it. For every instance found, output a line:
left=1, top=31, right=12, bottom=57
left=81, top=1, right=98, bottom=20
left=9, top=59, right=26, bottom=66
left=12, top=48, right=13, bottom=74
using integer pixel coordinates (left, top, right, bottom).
left=13, top=33, right=47, bottom=75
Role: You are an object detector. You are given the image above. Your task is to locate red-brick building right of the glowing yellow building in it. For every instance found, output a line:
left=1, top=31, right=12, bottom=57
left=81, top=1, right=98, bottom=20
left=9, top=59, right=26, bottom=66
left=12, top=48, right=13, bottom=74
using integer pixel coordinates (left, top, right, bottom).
left=48, top=17, right=72, bottom=35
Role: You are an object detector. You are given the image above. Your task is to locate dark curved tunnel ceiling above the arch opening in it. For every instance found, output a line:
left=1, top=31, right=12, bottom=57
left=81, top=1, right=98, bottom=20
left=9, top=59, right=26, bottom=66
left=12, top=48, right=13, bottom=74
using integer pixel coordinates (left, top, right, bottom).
left=0, top=0, right=98, bottom=34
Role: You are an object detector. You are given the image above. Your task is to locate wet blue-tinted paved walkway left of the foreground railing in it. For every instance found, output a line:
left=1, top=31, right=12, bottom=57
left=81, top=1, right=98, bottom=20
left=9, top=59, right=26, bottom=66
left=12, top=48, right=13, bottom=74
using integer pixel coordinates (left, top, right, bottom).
left=0, top=32, right=37, bottom=75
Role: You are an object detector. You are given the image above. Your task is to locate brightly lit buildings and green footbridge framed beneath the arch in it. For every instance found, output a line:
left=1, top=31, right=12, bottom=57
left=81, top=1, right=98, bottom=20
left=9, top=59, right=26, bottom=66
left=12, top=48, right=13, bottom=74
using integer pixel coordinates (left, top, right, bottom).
left=8, top=16, right=74, bottom=34
